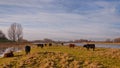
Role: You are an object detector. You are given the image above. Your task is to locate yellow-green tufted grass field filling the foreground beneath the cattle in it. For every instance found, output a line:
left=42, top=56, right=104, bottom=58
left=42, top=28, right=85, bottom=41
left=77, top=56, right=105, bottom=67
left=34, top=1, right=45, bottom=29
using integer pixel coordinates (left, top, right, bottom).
left=0, top=45, right=120, bottom=68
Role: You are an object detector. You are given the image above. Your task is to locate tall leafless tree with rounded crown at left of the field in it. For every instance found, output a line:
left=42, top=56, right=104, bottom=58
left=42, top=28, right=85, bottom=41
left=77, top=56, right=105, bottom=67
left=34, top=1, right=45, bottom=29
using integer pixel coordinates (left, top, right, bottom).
left=8, top=23, right=23, bottom=42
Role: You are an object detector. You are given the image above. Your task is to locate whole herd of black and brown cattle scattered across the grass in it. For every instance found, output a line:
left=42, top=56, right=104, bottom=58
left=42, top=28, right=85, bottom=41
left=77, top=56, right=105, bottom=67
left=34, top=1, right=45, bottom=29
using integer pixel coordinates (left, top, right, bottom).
left=3, top=43, right=95, bottom=57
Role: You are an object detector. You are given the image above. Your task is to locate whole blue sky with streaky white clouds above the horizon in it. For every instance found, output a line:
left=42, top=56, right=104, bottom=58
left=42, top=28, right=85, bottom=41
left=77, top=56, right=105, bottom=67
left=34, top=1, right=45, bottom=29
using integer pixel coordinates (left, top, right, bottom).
left=0, top=0, right=120, bottom=40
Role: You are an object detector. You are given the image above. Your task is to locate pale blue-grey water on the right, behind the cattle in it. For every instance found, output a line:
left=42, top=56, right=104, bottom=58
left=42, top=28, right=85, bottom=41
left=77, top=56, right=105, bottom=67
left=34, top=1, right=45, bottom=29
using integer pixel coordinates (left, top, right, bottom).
left=65, top=43, right=120, bottom=48
